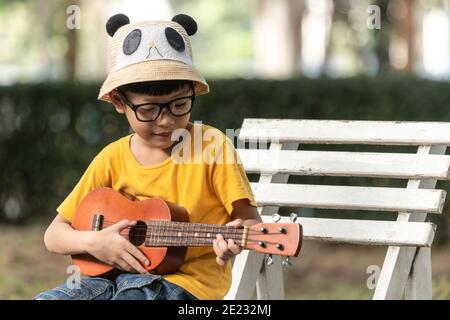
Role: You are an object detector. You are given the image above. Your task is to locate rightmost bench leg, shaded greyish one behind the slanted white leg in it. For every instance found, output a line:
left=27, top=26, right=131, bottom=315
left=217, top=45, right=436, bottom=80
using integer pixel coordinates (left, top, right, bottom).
left=405, top=248, right=433, bottom=300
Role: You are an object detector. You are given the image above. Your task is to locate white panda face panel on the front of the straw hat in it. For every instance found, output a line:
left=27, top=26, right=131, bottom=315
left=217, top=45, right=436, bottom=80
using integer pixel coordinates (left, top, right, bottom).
left=116, top=24, right=192, bottom=69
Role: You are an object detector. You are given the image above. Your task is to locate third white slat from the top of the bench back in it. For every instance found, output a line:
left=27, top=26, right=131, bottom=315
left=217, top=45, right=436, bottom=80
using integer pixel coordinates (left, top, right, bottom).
left=251, top=183, right=446, bottom=213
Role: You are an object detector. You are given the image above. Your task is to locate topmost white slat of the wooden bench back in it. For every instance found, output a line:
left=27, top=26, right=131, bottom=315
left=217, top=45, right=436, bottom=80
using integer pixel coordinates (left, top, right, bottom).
left=239, top=119, right=450, bottom=145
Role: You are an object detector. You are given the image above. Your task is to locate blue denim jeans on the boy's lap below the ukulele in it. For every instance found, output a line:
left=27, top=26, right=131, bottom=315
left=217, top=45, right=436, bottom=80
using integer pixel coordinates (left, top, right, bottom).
left=33, top=273, right=197, bottom=300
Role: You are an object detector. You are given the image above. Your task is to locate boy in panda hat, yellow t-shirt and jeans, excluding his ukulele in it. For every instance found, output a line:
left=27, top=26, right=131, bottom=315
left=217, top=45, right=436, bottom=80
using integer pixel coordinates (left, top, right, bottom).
left=36, top=14, right=260, bottom=299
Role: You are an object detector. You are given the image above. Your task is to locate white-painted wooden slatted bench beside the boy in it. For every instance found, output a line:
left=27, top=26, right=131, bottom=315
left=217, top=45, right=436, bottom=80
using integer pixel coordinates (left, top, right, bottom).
left=225, top=119, right=450, bottom=299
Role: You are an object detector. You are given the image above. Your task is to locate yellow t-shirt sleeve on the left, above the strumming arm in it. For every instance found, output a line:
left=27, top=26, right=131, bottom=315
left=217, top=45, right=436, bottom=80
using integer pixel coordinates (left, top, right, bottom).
left=56, top=152, right=111, bottom=221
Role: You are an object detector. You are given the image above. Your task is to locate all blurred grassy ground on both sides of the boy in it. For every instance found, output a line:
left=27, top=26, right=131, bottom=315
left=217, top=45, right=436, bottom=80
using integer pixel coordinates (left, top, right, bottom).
left=0, top=225, right=450, bottom=300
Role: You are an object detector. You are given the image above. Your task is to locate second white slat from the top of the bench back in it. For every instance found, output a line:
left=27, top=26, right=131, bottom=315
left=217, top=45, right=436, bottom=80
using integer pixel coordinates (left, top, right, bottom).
left=237, top=149, right=450, bottom=180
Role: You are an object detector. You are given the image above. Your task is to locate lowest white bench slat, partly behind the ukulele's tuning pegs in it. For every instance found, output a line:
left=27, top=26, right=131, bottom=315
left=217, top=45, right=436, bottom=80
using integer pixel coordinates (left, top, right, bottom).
left=262, top=216, right=436, bottom=247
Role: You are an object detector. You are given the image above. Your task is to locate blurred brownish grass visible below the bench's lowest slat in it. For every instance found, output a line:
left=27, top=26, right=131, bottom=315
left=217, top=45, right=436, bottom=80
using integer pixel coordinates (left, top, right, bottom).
left=284, top=242, right=450, bottom=300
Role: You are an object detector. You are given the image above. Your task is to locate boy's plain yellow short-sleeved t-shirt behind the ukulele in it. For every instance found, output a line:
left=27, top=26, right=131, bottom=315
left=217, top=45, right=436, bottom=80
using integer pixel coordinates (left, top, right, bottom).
left=57, top=123, right=256, bottom=299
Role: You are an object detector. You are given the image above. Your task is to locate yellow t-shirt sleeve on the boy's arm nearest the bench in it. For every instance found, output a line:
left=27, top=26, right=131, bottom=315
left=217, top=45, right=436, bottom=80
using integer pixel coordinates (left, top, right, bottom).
left=212, top=139, right=257, bottom=214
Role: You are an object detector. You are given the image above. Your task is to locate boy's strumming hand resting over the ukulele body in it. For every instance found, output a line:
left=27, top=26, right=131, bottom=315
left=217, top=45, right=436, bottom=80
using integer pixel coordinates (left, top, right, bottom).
left=87, top=220, right=149, bottom=274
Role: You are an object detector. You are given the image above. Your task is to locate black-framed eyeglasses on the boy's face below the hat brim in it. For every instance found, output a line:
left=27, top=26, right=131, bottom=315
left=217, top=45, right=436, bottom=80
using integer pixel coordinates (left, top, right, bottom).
left=117, top=85, right=195, bottom=122
